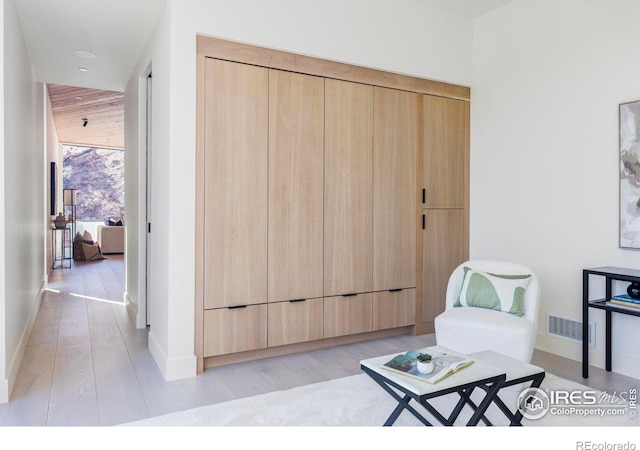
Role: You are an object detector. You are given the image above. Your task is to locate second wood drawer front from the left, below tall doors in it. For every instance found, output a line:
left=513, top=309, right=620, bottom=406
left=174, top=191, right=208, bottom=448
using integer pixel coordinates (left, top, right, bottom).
left=267, top=298, right=324, bottom=347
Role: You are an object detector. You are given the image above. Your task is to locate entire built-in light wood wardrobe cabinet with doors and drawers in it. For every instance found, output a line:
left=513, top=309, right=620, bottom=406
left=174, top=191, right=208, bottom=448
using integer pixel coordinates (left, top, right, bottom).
left=195, top=36, right=469, bottom=372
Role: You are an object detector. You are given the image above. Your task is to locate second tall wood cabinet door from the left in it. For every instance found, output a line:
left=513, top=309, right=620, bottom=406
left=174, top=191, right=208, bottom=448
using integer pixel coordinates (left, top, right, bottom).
left=268, top=70, right=324, bottom=302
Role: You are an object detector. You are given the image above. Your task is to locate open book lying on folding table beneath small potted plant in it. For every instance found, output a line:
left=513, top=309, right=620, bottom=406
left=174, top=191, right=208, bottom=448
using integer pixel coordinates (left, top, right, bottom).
left=382, top=350, right=473, bottom=384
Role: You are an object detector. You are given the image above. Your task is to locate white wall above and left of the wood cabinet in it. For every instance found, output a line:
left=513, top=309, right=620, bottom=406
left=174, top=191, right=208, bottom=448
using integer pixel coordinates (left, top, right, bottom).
left=127, top=0, right=472, bottom=379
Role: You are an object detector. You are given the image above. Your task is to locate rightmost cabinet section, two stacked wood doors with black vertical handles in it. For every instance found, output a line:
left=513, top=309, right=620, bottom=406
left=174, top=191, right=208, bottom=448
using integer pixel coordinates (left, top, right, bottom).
left=417, top=95, right=469, bottom=333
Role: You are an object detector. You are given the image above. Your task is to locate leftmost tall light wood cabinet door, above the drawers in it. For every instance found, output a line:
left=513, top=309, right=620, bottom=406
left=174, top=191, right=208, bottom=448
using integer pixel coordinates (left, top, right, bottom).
left=203, top=59, right=268, bottom=309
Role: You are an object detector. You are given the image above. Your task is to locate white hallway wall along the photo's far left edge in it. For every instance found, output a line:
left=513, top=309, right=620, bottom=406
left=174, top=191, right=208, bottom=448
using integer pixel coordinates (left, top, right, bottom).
left=0, top=2, right=45, bottom=402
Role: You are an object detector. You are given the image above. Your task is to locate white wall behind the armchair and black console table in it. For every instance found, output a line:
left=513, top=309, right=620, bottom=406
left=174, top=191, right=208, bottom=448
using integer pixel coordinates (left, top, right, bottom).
left=471, top=0, right=640, bottom=377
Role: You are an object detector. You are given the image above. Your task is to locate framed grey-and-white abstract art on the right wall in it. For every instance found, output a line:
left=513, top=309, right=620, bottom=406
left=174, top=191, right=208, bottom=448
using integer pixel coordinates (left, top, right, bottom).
left=619, top=101, right=640, bottom=249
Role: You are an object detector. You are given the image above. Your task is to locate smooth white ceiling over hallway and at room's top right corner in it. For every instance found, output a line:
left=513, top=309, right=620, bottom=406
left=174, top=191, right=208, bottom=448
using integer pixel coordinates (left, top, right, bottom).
left=13, top=0, right=509, bottom=91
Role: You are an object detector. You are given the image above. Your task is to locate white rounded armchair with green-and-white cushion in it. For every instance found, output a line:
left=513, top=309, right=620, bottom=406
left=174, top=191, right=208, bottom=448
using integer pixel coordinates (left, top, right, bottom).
left=435, top=260, right=540, bottom=362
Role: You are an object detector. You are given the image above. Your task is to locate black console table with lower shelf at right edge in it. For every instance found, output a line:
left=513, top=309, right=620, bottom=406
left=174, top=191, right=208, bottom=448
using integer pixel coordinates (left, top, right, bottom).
left=582, top=267, right=640, bottom=378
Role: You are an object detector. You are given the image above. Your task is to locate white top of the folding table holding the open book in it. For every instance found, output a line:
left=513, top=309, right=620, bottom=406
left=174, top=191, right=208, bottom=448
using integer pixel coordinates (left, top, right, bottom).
left=360, top=345, right=508, bottom=395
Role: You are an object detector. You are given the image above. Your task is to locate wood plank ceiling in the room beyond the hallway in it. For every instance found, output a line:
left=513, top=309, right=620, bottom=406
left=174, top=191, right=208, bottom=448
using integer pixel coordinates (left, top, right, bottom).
left=48, top=84, right=124, bottom=149
